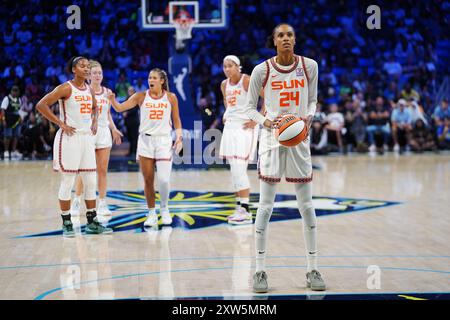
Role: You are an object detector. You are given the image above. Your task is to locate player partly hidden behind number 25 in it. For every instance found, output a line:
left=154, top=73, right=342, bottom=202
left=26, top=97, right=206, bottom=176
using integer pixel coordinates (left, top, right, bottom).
left=70, top=60, right=123, bottom=215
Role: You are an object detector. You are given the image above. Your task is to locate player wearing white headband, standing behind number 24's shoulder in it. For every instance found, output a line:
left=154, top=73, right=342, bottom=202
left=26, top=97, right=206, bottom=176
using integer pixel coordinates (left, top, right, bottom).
left=219, top=55, right=258, bottom=224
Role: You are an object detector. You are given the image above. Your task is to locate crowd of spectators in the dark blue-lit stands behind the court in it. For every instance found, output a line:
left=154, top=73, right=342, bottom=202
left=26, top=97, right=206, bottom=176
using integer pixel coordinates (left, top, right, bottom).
left=0, top=0, right=450, bottom=158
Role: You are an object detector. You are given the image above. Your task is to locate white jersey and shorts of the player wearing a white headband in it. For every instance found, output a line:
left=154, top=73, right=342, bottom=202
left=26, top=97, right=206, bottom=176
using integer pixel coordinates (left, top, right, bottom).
left=219, top=75, right=259, bottom=161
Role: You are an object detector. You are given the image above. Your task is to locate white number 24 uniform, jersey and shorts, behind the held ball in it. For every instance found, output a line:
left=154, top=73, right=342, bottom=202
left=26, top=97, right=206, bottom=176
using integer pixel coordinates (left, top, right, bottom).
left=244, top=56, right=317, bottom=183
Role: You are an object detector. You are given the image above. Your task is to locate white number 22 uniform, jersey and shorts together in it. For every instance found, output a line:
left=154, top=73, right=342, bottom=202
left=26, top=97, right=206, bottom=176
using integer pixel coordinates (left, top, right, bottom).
left=136, top=90, right=172, bottom=161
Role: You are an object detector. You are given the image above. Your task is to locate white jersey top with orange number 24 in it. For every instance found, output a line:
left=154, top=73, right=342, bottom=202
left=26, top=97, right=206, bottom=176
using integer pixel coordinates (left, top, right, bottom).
left=264, top=56, right=308, bottom=120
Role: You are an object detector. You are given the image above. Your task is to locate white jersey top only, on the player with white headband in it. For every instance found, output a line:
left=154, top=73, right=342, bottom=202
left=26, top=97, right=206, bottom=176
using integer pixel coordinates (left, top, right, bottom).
left=223, top=75, right=250, bottom=120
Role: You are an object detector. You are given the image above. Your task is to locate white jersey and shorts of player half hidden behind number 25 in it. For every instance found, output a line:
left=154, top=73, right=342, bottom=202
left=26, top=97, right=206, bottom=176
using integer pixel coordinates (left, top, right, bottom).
left=95, top=87, right=112, bottom=149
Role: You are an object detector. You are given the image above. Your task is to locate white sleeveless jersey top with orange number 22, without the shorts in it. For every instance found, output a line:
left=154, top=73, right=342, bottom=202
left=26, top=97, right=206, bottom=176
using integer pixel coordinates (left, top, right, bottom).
left=139, top=90, right=172, bottom=136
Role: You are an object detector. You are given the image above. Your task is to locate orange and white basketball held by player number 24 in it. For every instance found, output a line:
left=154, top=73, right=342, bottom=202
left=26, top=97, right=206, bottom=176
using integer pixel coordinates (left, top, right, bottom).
left=274, top=113, right=308, bottom=147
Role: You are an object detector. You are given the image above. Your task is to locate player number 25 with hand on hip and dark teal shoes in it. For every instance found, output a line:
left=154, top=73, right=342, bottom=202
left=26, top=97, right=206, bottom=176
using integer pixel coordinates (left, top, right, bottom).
left=36, top=57, right=112, bottom=237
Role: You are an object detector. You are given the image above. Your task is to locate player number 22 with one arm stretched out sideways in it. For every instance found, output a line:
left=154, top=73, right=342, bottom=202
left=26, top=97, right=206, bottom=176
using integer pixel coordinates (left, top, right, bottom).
left=110, top=69, right=183, bottom=227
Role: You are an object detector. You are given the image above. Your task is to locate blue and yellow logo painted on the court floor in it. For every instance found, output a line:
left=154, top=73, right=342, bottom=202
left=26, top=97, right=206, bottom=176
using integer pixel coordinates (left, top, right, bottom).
left=16, top=191, right=399, bottom=238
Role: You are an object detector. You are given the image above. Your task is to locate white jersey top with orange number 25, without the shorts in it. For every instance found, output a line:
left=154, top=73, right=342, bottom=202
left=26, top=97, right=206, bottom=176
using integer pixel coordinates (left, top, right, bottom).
left=59, top=81, right=92, bottom=132
